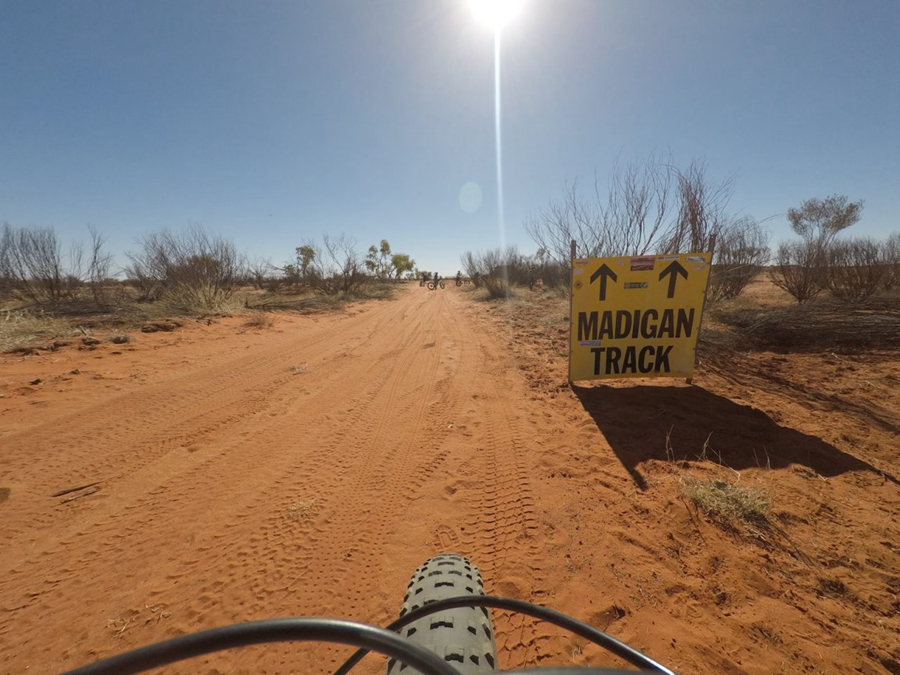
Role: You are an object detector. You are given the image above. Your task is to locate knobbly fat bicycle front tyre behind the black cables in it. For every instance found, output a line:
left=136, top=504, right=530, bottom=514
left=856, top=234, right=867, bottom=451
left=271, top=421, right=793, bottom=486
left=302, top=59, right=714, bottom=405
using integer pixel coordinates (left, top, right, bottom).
left=385, top=553, right=497, bottom=675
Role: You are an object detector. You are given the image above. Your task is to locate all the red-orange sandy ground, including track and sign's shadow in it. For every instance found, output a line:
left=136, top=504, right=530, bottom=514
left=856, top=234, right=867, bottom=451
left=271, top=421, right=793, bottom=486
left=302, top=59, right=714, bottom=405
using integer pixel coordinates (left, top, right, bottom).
left=0, top=287, right=900, bottom=675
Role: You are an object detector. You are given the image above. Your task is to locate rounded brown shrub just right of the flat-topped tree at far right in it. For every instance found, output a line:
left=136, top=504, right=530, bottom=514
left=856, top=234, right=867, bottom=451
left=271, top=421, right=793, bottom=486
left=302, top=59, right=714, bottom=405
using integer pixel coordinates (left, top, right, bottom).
left=822, top=239, right=886, bottom=301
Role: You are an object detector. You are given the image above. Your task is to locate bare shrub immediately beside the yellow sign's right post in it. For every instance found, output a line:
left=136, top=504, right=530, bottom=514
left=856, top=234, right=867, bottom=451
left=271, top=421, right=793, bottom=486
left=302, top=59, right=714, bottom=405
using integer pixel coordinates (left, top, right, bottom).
left=707, top=217, right=769, bottom=302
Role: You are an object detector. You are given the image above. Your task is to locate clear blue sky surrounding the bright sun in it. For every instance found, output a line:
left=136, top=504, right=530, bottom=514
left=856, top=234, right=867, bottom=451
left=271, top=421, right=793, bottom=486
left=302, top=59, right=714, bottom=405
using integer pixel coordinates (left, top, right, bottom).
left=0, top=0, right=900, bottom=274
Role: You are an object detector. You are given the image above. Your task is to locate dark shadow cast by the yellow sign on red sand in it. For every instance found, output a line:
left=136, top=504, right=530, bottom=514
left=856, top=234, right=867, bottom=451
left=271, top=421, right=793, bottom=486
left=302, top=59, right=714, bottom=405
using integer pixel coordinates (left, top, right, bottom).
left=572, top=385, right=900, bottom=490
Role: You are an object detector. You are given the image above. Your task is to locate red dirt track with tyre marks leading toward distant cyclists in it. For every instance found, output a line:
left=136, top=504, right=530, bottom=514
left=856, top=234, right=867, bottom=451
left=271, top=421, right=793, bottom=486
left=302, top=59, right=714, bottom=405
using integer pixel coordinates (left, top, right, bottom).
left=0, top=292, right=541, bottom=673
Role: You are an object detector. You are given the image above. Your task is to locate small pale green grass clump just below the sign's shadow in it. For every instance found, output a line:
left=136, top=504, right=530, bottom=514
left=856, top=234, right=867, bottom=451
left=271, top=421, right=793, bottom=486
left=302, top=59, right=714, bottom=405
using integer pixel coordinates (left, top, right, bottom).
left=681, top=477, right=772, bottom=532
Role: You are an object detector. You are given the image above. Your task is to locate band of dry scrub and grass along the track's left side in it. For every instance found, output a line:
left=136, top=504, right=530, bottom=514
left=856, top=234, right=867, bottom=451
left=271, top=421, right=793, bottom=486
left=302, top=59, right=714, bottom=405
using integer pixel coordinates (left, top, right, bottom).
left=0, top=223, right=415, bottom=351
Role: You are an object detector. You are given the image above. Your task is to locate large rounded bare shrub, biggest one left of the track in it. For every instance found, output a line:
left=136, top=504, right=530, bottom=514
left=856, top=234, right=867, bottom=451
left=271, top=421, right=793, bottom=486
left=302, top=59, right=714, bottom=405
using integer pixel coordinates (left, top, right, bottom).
left=125, top=225, right=245, bottom=311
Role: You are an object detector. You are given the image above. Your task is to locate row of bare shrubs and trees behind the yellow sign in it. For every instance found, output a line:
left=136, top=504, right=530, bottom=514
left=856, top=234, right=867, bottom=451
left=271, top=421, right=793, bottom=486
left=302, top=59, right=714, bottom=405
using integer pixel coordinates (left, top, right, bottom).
left=461, top=155, right=900, bottom=304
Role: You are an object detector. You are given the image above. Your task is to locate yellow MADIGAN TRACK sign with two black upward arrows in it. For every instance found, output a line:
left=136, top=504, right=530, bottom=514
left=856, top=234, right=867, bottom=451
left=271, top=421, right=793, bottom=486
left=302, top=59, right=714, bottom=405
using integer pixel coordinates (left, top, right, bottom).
left=569, top=253, right=711, bottom=381
